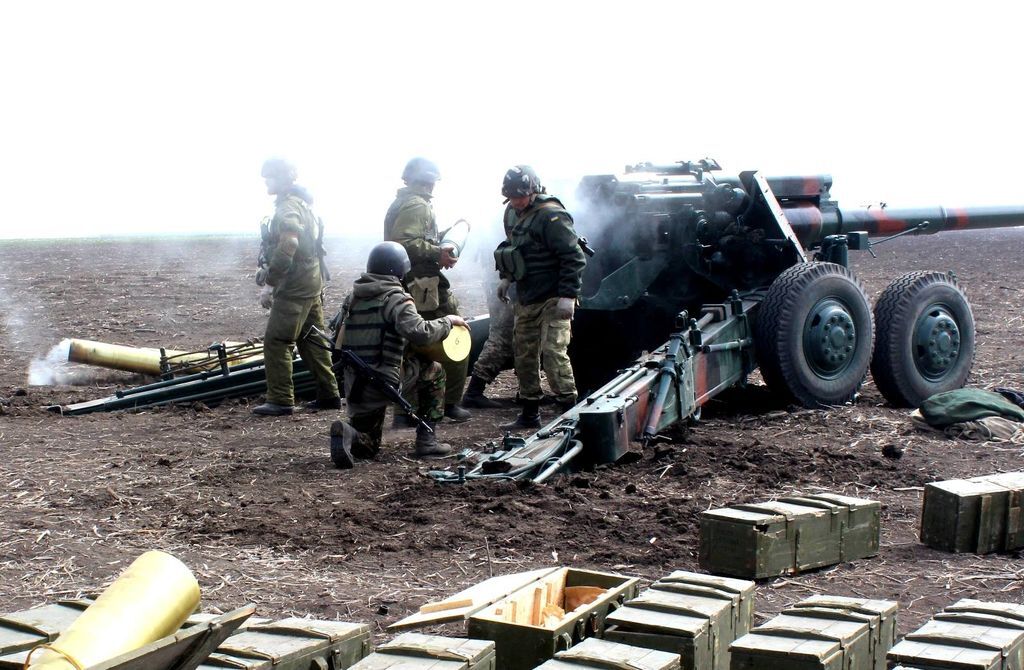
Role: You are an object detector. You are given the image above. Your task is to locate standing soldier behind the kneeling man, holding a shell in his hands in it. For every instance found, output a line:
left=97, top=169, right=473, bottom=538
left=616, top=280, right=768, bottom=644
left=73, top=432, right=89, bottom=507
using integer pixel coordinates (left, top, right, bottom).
left=384, top=158, right=471, bottom=427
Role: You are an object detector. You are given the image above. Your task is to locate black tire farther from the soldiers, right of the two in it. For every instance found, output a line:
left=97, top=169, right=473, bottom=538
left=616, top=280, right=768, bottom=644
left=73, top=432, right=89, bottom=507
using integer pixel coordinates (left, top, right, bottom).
left=871, top=271, right=975, bottom=407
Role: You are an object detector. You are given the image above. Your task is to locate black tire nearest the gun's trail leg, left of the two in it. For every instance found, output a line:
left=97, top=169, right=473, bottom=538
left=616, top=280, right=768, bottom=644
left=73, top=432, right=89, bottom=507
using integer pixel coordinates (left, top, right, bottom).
left=755, top=262, right=872, bottom=408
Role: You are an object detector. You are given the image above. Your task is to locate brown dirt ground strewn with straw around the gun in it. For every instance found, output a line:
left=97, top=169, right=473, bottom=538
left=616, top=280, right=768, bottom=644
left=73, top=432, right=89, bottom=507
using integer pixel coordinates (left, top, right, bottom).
left=0, top=229, right=1024, bottom=641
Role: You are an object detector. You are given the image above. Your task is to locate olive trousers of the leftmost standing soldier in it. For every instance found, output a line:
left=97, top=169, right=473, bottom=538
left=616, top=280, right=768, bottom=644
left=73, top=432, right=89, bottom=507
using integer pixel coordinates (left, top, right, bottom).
left=263, top=295, right=339, bottom=406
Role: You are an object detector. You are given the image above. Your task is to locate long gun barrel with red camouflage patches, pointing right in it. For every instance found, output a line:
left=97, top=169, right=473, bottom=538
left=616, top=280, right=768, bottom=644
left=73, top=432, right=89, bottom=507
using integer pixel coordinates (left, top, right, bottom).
left=784, top=204, right=1024, bottom=247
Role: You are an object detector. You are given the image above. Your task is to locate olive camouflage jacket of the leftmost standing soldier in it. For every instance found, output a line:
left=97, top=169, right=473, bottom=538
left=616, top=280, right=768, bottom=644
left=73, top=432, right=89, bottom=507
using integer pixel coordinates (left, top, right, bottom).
left=267, top=186, right=324, bottom=299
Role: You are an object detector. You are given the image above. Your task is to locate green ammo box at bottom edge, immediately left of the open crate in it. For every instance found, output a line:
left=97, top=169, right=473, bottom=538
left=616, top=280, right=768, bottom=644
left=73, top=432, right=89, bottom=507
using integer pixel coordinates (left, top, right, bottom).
left=351, top=633, right=497, bottom=670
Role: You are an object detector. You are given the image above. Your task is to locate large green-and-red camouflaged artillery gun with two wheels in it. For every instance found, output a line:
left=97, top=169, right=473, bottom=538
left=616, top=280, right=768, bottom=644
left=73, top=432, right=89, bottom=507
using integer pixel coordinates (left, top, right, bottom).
left=432, top=159, right=1024, bottom=481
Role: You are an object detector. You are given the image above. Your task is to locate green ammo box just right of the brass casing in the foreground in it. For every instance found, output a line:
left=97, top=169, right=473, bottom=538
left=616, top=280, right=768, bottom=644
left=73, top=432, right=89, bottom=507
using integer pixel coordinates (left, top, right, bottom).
left=199, top=618, right=371, bottom=670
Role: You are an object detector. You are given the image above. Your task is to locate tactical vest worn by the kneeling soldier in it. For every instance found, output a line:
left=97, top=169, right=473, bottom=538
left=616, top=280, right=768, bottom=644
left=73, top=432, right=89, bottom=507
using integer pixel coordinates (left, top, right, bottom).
left=342, top=289, right=407, bottom=387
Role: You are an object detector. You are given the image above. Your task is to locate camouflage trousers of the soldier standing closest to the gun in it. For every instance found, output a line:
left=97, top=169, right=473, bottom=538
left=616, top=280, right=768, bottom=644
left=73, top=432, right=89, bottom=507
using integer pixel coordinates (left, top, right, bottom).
left=513, top=298, right=577, bottom=403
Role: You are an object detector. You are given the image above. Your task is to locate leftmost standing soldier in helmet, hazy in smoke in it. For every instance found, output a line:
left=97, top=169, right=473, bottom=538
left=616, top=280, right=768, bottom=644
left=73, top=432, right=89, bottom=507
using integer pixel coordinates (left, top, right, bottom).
left=253, top=158, right=341, bottom=416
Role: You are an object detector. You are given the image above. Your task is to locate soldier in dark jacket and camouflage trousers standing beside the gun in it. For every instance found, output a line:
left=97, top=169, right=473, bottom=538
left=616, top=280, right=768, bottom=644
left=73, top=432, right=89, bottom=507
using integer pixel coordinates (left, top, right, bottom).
left=495, top=165, right=587, bottom=429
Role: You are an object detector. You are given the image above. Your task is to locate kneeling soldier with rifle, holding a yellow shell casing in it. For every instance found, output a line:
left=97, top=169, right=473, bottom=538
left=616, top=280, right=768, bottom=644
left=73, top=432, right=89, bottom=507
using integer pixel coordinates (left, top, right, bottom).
left=331, top=242, right=468, bottom=467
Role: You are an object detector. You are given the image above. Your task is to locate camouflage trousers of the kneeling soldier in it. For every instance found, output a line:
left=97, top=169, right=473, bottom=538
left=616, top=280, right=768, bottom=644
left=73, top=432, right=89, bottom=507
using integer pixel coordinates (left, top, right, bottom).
left=345, top=352, right=444, bottom=428
